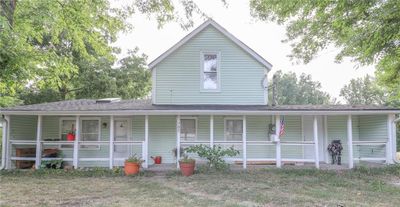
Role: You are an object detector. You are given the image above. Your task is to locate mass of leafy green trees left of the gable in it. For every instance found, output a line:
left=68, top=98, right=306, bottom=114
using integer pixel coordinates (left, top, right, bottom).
left=0, top=0, right=204, bottom=103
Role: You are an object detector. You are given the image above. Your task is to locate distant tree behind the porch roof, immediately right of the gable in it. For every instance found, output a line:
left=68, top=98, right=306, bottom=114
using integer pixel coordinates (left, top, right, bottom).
left=269, top=71, right=335, bottom=105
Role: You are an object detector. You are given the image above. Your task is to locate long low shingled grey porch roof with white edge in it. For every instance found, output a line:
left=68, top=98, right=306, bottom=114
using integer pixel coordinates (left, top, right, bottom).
left=0, top=99, right=400, bottom=114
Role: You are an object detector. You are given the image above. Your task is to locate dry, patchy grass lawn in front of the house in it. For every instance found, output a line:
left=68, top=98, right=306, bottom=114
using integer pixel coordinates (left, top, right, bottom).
left=0, top=166, right=400, bottom=206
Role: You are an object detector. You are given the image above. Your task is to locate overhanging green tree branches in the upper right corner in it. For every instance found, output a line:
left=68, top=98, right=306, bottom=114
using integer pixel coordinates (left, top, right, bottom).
left=250, top=0, right=400, bottom=98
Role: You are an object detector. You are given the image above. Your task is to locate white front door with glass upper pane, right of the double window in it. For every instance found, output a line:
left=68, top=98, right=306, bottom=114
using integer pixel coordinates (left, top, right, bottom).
left=114, top=119, right=130, bottom=164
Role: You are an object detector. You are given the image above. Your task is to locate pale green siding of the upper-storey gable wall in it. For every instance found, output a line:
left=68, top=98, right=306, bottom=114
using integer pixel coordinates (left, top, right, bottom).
left=155, top=26, right=265, bottom=105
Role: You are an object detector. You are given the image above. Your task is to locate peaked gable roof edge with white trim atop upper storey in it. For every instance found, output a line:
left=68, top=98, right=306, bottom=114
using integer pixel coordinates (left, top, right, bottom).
left=149, top=19, right=272, bottom=71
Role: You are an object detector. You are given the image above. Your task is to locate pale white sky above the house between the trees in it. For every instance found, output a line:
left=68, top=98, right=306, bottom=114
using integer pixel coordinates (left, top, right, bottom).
left=115, top=0, right=374, bottom=102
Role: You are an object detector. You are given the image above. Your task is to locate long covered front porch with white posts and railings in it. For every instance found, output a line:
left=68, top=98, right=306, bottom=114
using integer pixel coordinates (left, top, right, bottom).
left=3, top=114, right=396, bottom=169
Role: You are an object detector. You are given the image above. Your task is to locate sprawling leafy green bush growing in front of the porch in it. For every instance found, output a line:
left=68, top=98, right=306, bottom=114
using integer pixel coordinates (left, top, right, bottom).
left=185, top=144, right=239, bottom=170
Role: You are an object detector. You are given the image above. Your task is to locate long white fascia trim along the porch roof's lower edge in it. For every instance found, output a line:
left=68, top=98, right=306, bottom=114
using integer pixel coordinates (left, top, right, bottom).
left=0, top=109, right=400, bottom=116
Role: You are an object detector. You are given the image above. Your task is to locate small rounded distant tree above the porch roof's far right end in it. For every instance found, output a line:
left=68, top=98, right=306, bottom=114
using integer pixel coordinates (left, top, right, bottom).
left=340, top=75, right=388, bottom=105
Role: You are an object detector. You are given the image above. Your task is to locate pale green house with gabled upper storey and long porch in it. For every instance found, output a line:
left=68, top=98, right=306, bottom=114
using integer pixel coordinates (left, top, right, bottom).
left=0, top=20, right=400, bottom=169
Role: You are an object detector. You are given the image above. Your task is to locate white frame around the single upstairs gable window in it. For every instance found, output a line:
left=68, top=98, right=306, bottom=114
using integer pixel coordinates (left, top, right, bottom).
left=200, top=51, right=221, bottom=92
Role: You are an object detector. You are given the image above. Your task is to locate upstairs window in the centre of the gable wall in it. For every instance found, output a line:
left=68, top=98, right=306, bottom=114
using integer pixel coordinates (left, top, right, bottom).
left=201, top=52, right=220, bottom=91
